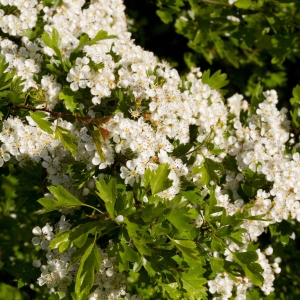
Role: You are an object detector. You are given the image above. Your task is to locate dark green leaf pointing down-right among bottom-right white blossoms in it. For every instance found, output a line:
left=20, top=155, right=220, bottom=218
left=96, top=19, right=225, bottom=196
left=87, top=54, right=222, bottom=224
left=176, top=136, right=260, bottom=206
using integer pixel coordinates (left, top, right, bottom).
left=232, top=251, right=264, bottom=286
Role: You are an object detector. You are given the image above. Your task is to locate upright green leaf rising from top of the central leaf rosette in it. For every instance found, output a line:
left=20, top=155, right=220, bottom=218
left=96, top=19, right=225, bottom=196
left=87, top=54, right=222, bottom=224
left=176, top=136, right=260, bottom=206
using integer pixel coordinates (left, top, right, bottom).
left=96, top=178, right=117, bottom=219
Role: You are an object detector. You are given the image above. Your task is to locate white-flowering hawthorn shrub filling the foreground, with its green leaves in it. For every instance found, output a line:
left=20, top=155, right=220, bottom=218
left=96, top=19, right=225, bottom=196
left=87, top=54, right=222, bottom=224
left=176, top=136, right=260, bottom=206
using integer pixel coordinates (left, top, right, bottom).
left=0, top=0, right=300, bottom=300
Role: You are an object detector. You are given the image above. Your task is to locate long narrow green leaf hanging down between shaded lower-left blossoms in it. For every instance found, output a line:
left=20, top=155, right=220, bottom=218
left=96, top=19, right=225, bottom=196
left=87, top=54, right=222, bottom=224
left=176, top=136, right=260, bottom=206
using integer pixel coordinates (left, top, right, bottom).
left=75, top=244, right=102, bottom=300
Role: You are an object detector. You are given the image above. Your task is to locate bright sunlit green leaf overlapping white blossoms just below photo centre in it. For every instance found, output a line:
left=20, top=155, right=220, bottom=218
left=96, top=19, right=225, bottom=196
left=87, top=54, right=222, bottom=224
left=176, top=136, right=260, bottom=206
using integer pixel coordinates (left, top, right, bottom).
left=150, top=164, right=172, bottom=195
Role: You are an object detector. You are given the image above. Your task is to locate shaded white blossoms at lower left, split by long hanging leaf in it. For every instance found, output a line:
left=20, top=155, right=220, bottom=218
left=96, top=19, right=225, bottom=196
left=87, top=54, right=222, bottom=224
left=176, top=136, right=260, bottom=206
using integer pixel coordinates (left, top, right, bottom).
left=32, top=215, right=139, bottom=300
